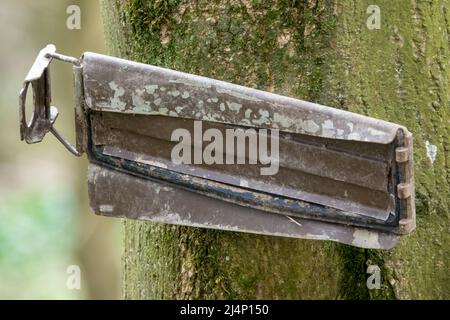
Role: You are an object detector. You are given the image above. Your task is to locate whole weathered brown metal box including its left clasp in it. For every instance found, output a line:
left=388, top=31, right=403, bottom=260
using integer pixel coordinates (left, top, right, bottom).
left=20, top=45, right=415, bottom=249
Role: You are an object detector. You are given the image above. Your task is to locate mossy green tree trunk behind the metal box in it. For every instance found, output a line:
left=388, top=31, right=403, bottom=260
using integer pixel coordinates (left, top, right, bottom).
left=102, top=0, right=450, bottom=299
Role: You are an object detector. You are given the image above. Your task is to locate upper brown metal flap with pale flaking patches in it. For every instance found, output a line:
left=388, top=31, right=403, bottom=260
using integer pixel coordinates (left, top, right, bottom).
left=82, top=52, right=407, bottom=144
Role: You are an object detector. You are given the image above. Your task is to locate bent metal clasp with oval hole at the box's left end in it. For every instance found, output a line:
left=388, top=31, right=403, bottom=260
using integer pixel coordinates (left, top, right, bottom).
left=19, top=44, right=81, bottom=156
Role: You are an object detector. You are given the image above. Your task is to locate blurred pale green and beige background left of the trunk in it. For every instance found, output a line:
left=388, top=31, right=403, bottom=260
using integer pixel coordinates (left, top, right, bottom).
left=0, top=0, right=122, bottom=299
